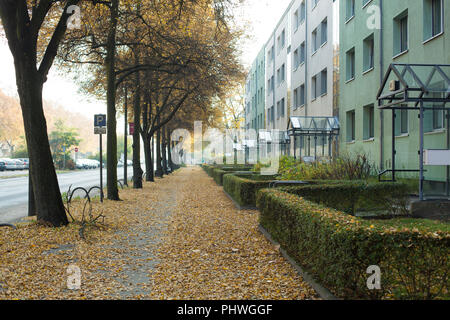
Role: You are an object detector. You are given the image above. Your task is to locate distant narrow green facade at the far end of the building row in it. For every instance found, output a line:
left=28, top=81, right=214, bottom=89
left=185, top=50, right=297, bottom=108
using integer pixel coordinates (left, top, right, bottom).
left=245, top=47, right=266, bottom=131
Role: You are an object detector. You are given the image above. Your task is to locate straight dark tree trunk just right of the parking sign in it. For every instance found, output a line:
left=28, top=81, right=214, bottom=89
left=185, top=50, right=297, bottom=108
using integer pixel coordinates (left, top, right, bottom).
left=105, top=0, right=120, bottom=200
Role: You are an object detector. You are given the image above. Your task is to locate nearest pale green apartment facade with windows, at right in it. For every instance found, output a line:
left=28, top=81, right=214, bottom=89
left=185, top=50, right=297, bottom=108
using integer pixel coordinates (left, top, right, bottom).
left=339, top=0, right=450, bottom=192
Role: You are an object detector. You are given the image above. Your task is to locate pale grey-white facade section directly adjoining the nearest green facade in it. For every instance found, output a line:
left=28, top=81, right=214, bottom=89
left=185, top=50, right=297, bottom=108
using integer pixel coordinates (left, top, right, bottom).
left=291, top=0, right=335, bottom=116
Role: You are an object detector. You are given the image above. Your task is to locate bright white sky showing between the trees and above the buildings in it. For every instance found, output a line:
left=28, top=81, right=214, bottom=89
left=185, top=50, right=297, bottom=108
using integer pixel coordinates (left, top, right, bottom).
left=0, top=0, right=310, bottom=131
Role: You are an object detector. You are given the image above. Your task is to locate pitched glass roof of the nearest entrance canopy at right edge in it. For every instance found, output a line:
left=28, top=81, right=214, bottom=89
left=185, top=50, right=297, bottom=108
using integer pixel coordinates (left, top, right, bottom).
left=377, top=64, right=450, bottom=109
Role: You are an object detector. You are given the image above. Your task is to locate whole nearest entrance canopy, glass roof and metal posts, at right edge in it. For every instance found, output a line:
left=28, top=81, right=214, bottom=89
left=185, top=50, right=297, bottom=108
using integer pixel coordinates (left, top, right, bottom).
left=377, top=64, right=450, bottom=200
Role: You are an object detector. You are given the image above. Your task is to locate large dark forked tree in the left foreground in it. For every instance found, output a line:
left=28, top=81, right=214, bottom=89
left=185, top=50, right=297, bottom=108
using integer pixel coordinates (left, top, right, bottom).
left=0, top=0, right=80, bottom=226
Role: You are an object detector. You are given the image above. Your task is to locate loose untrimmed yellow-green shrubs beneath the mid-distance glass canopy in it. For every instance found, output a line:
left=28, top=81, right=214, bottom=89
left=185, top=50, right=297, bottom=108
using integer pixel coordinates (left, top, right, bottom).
left=278, top=155, right=374, bottom=180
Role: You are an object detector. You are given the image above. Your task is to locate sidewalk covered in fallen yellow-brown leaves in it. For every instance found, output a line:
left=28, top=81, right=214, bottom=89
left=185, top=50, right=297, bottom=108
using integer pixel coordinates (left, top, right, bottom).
left=0, top=167, right=317, bottom=299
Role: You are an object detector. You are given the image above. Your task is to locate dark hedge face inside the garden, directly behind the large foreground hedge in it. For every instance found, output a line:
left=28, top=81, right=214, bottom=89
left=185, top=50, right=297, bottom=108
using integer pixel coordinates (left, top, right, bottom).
left=281, top=181, right=409, bottom=215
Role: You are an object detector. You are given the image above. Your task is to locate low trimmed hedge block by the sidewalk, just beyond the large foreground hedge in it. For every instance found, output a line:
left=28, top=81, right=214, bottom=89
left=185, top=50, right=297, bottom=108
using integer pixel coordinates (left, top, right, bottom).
left=223, top=174, right=275, bottom=207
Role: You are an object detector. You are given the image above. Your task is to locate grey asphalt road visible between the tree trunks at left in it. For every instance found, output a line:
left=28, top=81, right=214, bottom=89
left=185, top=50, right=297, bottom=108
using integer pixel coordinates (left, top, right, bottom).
left=0, top=167, right=137, bottom=223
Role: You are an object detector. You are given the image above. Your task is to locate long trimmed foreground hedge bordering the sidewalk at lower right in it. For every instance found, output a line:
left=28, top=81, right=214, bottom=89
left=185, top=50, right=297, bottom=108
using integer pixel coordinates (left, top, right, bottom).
left=257, top=189, right=450, bottom=299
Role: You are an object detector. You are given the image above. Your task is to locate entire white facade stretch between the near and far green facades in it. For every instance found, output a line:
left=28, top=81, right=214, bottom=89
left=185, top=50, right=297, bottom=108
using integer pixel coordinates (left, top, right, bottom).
left=265, top=0, right=338, bottom=130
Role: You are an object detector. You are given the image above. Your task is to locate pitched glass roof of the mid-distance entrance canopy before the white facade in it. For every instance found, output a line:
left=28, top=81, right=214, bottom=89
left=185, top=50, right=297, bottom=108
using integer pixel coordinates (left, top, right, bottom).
left=288, top=117, right=340, bottom=136
